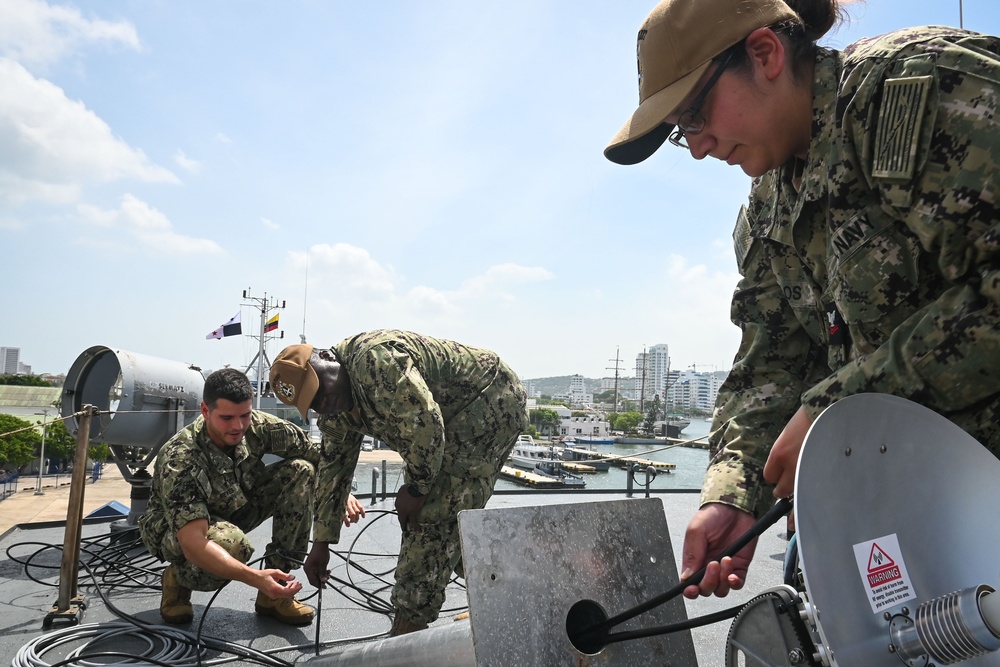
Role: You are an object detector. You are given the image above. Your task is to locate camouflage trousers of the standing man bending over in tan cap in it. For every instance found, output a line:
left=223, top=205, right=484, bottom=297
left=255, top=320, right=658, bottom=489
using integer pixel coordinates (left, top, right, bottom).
left=391, top=366, right=528, bottom=624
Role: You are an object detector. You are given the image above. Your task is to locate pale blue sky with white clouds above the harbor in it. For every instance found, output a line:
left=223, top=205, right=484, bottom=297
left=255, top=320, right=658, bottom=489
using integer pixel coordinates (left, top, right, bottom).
left=0, top=0, right=1000, bottom=377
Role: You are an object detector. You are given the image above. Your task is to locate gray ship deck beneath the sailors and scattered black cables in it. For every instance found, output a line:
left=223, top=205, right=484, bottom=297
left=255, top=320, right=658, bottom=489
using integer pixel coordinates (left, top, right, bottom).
left=0, top=490, right=786, bottom=667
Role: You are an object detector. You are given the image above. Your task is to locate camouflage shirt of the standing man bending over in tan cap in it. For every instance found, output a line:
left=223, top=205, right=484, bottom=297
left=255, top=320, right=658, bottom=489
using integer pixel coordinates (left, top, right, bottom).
left=313, top=330, right=527, bottom=542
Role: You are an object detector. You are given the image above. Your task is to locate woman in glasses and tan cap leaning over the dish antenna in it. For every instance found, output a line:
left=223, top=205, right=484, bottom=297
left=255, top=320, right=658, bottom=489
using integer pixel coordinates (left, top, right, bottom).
left=605, top=0, right=1000, bottom=597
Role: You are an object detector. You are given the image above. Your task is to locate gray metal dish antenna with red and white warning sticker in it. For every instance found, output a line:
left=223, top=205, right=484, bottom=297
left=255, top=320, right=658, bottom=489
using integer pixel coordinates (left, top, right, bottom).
left=795, top=394, right=1000, bottom=667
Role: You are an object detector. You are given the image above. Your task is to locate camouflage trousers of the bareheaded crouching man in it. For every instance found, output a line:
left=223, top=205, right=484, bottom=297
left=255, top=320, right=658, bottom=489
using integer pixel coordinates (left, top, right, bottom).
left=170, top=459, right=316, bottom=591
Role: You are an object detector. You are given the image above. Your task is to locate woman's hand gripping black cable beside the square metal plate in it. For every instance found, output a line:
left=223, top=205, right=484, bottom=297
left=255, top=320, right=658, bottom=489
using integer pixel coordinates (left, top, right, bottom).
left=681, top=503, right=757, bottom=600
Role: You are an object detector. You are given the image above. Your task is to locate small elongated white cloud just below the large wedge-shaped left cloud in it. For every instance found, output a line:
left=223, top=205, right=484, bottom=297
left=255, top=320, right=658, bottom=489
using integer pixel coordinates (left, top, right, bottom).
left=77, top=194, right=225, bottom=255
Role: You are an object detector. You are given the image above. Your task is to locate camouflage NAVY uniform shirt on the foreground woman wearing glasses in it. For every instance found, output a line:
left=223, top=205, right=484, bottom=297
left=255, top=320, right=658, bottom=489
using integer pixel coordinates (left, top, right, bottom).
left=702, top=27, right=1000, bottom=516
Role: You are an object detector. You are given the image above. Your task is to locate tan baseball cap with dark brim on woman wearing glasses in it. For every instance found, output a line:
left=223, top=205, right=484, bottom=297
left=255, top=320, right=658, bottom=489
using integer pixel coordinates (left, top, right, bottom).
left=604, top=0, right=798, bottom=164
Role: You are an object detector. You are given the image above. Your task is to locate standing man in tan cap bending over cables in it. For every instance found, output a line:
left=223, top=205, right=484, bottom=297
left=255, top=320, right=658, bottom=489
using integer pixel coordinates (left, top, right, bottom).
left=271, top=330, right=527, bottom=635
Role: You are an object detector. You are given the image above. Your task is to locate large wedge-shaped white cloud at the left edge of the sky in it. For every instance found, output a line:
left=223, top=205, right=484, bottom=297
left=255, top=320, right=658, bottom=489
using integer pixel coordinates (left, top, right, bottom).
left=0, top=58, right=179, bottom=205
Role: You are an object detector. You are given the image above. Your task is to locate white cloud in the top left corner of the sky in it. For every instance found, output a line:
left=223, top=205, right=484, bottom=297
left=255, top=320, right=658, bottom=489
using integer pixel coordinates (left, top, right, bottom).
left=0, top=0, right=140, bottom=65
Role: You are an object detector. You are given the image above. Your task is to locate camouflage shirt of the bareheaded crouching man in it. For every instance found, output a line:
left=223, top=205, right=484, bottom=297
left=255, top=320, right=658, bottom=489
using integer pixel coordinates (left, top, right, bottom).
left=139, top=410, right=319, bottom=560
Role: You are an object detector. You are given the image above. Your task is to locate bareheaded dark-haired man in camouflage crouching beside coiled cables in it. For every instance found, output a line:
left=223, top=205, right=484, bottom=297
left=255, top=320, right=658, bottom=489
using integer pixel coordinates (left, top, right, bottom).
left=139, top=368, right=319, bottom=625
